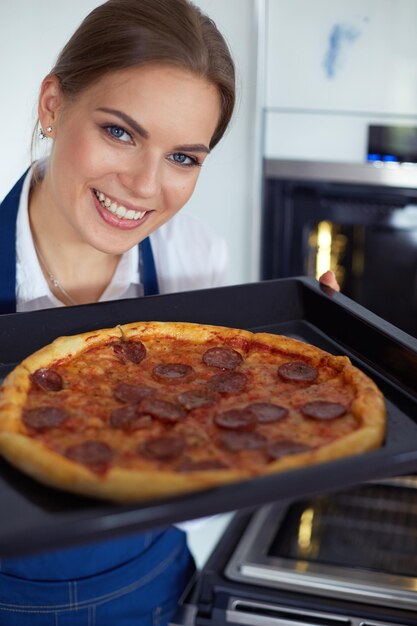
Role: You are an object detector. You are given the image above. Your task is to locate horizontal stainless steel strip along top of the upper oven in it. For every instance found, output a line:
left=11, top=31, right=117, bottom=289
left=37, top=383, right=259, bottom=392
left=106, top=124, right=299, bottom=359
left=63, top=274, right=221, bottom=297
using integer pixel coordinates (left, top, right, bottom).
left=264, top=159, right=417, bottom=189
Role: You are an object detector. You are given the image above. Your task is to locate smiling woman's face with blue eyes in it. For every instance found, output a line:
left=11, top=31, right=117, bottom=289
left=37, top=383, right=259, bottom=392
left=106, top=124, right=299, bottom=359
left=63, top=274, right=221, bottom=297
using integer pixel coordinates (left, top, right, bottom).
left=41, top=64, right=220, bottom=254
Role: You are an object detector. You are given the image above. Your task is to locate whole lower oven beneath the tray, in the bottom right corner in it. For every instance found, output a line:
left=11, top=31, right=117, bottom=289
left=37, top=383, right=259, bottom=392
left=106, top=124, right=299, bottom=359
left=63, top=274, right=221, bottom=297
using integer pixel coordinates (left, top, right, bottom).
left=171, top=476, right=417, bottom=626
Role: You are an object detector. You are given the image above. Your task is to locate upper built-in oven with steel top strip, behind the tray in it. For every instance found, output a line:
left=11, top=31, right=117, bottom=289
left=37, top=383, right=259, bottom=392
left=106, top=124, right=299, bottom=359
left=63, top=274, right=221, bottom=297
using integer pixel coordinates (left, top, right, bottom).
left=261, top=160, right=417, bottom=336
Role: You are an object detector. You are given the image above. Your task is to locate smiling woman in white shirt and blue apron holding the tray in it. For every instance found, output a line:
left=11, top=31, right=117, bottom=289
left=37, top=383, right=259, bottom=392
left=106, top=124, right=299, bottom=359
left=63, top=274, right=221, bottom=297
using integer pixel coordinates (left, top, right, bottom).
left=0, top=0, right=338, bottom=626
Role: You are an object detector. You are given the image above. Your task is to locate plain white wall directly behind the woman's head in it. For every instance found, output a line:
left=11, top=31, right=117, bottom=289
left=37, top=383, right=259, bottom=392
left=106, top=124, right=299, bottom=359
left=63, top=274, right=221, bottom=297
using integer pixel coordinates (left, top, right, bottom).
left=0, top=0, right=256, bottom=283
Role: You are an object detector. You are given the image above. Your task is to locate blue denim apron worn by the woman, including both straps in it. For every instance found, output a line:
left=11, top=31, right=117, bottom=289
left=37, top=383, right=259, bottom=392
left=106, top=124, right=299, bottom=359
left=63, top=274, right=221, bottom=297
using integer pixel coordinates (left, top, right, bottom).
left=0, top=174, right=194, bottom=626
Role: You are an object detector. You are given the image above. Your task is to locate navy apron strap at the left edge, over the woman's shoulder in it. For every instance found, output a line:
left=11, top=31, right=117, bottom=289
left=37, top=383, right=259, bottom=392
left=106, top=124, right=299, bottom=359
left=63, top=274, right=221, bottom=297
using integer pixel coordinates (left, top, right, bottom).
left=0, top=171, right=27, bottom=314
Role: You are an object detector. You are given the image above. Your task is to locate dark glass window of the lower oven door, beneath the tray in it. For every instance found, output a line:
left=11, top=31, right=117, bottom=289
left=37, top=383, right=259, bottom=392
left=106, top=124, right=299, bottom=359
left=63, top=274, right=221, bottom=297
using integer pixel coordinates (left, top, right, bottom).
left=269, top=484, right=417, bottom=576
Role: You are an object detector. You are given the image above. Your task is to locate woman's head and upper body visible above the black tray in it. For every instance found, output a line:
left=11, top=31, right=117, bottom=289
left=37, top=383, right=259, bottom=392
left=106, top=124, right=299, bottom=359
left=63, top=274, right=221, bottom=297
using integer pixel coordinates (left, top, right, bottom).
left=0, top=0, right=235, bottom=312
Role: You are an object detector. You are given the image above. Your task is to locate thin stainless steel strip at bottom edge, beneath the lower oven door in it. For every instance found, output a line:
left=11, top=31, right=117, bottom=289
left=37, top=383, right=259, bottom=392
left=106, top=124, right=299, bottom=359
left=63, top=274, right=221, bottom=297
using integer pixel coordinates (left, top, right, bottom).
left=226, top=597, right=399, bottom=626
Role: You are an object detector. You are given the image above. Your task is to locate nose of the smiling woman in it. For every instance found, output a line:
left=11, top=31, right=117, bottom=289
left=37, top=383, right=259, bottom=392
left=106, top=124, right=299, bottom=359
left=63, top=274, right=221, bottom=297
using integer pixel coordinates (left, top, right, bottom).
left=119, top=153, right=161, bottom=199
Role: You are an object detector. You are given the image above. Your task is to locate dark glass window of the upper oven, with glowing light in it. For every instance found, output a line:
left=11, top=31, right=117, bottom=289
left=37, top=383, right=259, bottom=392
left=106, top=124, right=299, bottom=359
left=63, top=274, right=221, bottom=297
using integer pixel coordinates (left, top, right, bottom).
left=304, top=218, right=417, bottom=336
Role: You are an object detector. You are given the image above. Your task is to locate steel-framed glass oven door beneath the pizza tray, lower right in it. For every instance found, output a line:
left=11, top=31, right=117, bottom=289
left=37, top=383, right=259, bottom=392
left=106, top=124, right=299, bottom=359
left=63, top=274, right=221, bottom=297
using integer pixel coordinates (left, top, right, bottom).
left=226, top=477, right=417, bottom=608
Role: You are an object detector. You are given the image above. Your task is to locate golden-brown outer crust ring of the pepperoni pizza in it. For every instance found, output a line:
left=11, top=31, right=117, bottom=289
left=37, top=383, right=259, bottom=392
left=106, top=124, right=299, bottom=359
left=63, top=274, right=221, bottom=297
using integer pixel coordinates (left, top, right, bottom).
left=0, top=322, right=386, bottom=502
